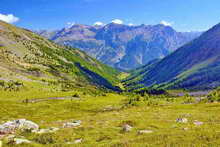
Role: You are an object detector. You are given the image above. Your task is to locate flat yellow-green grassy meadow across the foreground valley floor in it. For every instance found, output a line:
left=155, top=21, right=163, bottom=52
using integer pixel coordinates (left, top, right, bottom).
left=0, top=92, right=220, bottom=147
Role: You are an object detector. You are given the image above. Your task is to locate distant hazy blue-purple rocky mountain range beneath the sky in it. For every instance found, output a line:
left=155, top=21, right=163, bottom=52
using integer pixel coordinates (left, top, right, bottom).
left=37, top=23, right=201, bottom=70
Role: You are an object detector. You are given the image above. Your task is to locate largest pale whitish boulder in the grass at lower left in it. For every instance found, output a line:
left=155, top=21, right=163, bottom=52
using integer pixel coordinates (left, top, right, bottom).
left=0, top=119, right=39, bottom=134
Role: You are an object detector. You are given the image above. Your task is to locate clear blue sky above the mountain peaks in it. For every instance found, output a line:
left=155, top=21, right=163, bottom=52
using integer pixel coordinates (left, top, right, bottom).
left=0, top=0, right=220, bottom=31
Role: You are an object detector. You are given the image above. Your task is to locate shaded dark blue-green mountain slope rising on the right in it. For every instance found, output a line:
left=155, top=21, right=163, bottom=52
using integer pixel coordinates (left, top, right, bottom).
left=125, top=24, right=220, bottom=89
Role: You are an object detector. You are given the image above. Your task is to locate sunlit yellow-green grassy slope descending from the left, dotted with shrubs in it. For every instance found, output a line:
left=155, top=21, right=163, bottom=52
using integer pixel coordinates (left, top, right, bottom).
left=0, top=22, right=119, bottom=92
